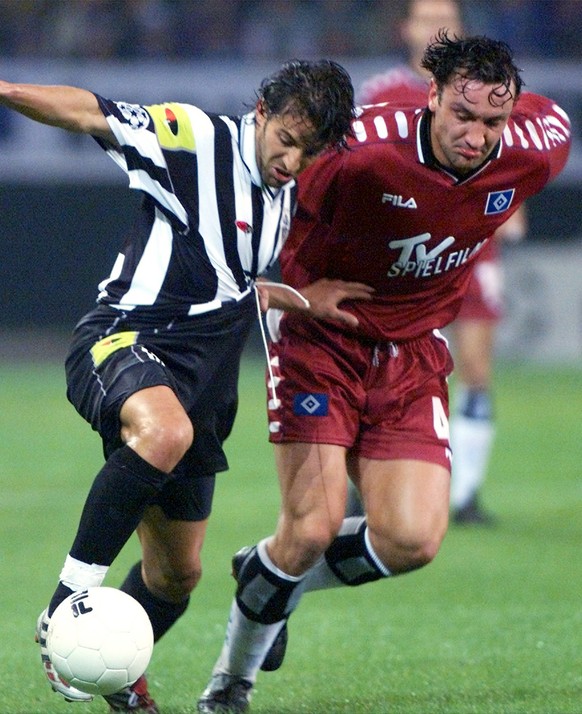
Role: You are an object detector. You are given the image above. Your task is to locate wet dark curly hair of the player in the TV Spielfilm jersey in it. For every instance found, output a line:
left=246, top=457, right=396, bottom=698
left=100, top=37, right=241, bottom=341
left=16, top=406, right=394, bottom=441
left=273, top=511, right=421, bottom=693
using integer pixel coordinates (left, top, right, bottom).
left=421, top=29, right=523, bottom=104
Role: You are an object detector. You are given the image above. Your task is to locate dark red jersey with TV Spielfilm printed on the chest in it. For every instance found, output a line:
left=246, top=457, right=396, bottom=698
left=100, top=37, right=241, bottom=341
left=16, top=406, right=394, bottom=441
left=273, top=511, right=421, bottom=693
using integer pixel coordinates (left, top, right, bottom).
left=281, top=94, right=571, bottom=340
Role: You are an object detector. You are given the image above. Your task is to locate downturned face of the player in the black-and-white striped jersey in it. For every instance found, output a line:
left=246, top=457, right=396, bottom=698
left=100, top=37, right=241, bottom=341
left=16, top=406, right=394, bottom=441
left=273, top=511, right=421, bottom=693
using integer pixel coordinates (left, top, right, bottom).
left=255, top=105, right=323, bottom=188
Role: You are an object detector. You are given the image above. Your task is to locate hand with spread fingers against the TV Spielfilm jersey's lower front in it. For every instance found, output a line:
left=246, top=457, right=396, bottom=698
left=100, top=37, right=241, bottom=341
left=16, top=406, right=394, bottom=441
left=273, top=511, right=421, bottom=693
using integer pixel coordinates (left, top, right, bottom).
left=301, top=278, right=374, bottom=327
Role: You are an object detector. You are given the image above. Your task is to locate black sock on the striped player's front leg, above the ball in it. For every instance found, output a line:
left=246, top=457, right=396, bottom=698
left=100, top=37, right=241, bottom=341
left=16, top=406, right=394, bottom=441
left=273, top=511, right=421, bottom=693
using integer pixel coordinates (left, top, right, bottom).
left=70, top=446, right=168, bottom=565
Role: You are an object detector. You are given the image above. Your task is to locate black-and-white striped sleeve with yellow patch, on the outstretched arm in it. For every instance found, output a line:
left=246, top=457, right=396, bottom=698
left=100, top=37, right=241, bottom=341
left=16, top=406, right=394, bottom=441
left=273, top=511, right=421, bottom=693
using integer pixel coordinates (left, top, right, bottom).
left=96, top=95, right=189, bottom=230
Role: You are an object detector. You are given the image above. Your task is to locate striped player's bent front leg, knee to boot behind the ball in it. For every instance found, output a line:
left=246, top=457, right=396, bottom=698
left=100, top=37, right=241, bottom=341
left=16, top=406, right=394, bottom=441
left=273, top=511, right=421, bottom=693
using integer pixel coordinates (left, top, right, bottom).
left=37, top=386, right=193, bottom=701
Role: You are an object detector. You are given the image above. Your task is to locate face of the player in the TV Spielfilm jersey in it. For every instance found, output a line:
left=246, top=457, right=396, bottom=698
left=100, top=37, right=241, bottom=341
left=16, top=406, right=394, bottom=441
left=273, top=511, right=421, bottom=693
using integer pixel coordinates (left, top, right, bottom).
left=428, top=77, right=514, bottom=173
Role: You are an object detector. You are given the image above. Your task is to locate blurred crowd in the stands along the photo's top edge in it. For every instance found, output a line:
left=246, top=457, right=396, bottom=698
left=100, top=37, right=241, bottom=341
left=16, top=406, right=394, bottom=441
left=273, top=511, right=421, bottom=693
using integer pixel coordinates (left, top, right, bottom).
left=0, top=0, right=582, bottom=60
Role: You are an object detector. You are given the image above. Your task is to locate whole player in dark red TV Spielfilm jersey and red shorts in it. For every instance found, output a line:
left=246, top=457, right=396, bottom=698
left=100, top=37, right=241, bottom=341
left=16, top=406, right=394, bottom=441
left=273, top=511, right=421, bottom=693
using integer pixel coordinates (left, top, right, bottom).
left=198, top=33, right=571, bottom=714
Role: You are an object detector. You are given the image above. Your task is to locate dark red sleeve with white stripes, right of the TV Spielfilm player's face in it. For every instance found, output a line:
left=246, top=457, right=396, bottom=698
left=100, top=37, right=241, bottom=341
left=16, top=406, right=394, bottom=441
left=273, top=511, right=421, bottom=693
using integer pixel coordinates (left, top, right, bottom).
left=503, top=92, right=572, bottom=181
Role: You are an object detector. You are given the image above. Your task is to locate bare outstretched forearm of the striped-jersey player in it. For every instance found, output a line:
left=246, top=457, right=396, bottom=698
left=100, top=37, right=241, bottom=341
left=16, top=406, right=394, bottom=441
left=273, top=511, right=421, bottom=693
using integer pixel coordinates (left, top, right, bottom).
left=0, top=81, right=115, bottom=142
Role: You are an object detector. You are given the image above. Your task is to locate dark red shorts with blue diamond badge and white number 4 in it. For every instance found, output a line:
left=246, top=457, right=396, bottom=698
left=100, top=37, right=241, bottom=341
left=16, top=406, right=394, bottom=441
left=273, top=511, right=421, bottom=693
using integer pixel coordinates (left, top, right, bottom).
left=267, top=317, right=453, bottom=469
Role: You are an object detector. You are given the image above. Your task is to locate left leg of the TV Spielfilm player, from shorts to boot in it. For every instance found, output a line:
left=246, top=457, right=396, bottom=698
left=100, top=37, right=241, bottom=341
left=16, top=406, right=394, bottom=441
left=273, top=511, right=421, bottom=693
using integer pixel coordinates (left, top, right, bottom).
left=198, top=444, right=347, bottom=714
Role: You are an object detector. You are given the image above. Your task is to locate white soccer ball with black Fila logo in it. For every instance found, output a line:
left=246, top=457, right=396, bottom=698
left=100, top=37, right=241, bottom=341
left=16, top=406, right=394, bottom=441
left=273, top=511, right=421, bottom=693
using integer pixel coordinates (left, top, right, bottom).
left=46, top=587, right=154, bottom=695
